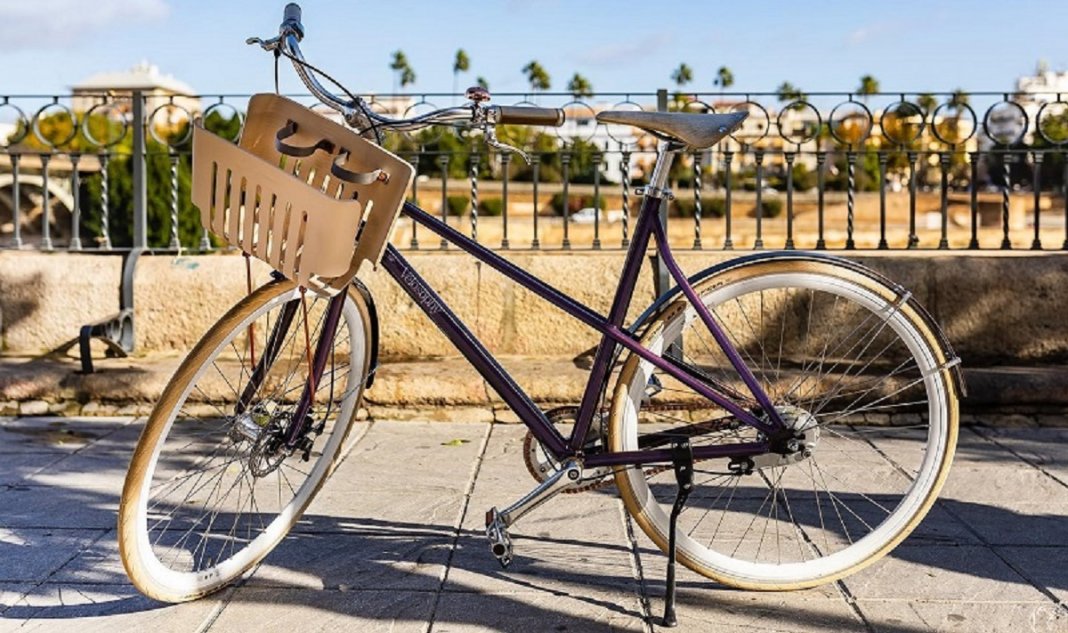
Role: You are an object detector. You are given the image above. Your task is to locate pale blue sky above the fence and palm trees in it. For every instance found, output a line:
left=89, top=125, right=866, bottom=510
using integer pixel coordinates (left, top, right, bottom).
left=0, top=0, right=1068, bottom=94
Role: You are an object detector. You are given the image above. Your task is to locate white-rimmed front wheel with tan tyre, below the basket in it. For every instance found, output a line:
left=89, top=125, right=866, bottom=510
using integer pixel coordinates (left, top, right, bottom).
left=119, top=282, right=372, bottom=602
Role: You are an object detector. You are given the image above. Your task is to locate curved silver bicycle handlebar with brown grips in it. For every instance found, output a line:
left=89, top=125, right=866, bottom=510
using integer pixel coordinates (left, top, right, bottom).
left=254, top=2, right=564, bottom=147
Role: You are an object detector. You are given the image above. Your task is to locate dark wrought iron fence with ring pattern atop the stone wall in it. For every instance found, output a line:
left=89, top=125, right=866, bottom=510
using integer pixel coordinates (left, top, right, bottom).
left=0, top=90, right=1068, bottom=252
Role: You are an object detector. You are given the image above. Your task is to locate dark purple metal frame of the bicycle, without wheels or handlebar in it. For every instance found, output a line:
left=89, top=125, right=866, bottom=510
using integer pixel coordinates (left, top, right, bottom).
left=373, top=196, right=786, bottom=468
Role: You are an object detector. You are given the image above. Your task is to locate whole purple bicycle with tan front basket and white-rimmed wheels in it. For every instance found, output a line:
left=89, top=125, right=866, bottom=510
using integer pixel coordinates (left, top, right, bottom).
left=119, top=4, right=962, bottom=622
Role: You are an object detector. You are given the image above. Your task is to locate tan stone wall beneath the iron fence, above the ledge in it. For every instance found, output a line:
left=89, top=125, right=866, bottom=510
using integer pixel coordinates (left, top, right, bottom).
left=0, top=251, right=1068, bottom=366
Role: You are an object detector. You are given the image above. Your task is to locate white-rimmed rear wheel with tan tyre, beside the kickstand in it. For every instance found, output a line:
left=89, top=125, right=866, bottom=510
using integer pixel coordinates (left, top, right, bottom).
left=608, top=258, right=957, bottom=590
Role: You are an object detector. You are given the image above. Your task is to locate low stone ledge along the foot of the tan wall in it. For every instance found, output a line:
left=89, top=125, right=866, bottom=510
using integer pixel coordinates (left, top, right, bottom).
left=0, top=357, right=1068, bottom=426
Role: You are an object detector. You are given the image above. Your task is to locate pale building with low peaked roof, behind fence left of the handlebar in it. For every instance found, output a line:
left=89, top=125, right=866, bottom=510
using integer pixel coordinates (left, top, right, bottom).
left=70, top=61, right=201, bottom=127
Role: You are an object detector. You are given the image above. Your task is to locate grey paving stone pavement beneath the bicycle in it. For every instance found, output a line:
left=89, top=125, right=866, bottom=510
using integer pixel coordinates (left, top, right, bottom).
left=0, top=417, right=1068, bottom=633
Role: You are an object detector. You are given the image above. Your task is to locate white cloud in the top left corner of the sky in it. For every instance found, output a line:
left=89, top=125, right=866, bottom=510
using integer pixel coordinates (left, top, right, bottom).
left=0, top=0, right=170, bottom=51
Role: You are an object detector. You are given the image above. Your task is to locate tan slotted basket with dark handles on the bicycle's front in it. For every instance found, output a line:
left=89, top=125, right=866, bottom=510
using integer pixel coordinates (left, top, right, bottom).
left=192, top=94, right=414, bottom=295
